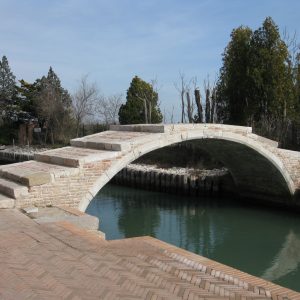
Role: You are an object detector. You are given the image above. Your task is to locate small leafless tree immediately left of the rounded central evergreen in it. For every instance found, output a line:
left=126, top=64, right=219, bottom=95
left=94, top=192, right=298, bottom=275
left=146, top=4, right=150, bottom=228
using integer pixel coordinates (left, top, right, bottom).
left=95, top=94, right=123, bottom=125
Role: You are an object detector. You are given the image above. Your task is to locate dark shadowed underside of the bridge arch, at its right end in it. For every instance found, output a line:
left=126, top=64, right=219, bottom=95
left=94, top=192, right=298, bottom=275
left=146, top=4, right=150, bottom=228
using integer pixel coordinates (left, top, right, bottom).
left=195, top=139, right=291, bottom=204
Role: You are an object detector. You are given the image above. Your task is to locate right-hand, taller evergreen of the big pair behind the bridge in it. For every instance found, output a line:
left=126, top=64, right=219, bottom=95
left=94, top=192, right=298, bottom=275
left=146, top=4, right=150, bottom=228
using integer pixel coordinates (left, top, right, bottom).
left=249, top=17, right=295, bottom=141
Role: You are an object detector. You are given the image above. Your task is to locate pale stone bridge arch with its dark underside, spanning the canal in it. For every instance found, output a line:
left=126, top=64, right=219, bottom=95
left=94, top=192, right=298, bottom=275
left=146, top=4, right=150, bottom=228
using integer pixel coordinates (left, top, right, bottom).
left=75, top=124, right=295, bottom=211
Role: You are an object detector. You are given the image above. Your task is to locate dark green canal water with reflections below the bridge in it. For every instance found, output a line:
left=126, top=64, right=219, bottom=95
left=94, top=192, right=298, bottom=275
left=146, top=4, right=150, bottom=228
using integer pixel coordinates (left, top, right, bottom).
left=87, top=185, right=300, bottom=291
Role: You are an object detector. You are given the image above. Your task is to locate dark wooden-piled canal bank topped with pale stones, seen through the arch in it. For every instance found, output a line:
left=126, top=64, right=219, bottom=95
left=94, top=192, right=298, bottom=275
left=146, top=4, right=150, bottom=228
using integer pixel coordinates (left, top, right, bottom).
left=112, top=164, right=235, bottom=197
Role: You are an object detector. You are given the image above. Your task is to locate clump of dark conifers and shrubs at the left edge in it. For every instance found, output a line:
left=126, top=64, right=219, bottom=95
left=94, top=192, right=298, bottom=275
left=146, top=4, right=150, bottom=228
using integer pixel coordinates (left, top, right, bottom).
left=0, top=56, right=73, bottom=144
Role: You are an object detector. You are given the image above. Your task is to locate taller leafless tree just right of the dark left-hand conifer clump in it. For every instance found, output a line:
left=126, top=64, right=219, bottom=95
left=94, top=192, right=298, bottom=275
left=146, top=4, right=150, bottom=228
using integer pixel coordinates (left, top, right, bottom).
left=72, top=75, right=99, bottom=137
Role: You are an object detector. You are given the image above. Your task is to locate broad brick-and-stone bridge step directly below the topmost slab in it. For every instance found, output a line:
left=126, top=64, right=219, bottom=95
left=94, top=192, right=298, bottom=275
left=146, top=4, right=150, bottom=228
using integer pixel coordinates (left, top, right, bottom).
left=71, top=130, right=153, bottom=151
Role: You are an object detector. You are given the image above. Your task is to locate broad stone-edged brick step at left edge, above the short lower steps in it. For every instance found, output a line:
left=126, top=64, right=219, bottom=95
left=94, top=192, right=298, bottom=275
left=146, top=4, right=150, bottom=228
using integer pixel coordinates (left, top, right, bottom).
left=0, top=160, right=79, bottom=187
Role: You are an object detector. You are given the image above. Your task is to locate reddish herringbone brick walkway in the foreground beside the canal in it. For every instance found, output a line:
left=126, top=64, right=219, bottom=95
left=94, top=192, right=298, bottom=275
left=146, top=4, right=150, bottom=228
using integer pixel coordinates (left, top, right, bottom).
left=0, top=209, right=300, bottom=300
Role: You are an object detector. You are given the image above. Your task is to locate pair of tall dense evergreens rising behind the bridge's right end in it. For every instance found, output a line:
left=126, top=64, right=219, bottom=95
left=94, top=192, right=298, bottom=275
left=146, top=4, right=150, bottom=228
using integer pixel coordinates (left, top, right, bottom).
left=216, top=17, right=295, bottom=144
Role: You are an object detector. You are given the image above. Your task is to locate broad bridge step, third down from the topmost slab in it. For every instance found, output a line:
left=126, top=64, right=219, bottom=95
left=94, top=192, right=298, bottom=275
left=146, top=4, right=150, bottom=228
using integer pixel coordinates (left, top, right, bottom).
left=34, top=146, right=119, bottom=167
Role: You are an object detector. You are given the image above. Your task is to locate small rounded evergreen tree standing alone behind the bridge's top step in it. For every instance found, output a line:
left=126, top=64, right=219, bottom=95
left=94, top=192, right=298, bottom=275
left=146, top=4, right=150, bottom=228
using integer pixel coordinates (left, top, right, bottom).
left=119, top=76, right=162, bottom=124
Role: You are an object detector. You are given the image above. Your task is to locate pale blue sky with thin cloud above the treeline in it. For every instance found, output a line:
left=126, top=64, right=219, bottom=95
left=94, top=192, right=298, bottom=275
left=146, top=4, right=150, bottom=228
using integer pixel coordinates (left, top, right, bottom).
left=0, top=0, right=300, bottom=121
